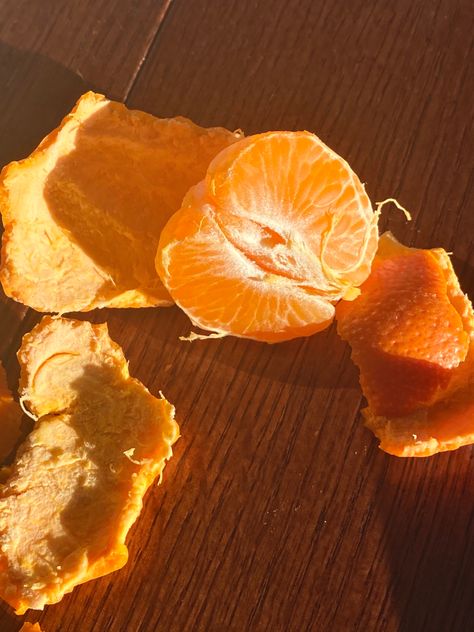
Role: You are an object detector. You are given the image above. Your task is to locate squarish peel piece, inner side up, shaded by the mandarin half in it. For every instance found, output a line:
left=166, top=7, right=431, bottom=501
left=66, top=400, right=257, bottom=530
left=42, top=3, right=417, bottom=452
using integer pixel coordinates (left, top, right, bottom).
left=0, top=92, right=241, bottom=313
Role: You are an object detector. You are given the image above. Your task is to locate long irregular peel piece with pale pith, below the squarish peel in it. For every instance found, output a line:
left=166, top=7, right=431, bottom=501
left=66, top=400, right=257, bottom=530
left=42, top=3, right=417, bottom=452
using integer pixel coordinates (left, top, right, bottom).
left=0, top=316, right=178, bottom=614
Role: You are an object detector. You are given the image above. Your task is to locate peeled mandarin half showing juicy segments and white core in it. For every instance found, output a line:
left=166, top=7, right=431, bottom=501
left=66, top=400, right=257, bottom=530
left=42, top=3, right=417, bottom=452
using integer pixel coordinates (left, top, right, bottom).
left=156, top=132, right=378, bottom=342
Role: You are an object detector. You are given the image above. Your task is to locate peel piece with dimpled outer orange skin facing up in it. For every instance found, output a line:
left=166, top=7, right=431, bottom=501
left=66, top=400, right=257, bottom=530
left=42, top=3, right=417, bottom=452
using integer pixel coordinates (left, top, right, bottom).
left=336, top=233, right=474, bottom=456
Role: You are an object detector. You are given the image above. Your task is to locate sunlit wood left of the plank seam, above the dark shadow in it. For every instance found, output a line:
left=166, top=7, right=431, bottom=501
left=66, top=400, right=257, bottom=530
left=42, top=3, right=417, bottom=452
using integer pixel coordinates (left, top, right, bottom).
left=0, top=0, right=170, bottom=99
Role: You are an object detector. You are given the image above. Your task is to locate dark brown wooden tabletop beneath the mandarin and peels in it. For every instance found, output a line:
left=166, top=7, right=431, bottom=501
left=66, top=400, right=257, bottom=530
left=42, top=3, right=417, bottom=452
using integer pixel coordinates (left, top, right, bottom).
left=0, top=0, right=474, bottom=632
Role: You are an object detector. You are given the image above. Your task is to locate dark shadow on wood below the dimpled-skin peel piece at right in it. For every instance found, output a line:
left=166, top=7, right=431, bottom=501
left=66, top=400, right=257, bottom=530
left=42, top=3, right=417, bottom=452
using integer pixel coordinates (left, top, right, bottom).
left=378, top=447, right=474, bottom=632
